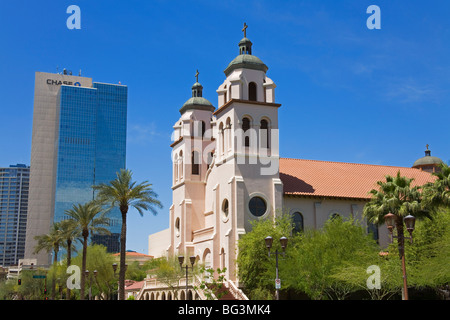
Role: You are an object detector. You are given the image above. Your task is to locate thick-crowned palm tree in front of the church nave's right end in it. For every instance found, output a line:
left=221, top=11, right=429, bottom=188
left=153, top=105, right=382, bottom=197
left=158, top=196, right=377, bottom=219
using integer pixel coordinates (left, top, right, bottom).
left=363, top=171, right=431, bottom=300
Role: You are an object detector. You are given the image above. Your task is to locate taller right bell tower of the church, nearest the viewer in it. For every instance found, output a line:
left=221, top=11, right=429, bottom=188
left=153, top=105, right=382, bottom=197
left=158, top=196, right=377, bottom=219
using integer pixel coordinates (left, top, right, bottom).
left=206, top=24, right=283, bottom=279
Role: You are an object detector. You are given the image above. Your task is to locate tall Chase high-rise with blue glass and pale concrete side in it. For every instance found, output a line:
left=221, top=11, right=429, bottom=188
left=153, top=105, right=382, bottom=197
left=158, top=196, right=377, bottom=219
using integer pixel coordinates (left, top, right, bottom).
left=25, top=72, right=128, bottom=264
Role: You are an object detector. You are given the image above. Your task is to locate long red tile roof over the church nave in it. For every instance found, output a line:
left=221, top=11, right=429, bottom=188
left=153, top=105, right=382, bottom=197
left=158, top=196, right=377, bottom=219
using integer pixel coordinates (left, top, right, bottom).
left=280, top=158, right=434, bottom=200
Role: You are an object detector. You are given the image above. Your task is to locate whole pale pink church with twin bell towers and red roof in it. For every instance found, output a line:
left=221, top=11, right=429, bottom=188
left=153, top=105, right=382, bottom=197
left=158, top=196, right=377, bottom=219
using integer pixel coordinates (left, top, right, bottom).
left=148, top=25, right=440, bottom=281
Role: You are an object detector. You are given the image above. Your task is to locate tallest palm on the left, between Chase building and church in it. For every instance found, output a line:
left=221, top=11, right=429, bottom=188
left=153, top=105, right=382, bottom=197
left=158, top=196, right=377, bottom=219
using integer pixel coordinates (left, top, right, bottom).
left=93, top=169, right=162, bottom=300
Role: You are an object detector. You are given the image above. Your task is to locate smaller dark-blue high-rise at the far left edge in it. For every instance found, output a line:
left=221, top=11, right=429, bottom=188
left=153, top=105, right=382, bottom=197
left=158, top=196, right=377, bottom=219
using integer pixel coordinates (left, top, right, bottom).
left=0, top=164, right=30, bottom=267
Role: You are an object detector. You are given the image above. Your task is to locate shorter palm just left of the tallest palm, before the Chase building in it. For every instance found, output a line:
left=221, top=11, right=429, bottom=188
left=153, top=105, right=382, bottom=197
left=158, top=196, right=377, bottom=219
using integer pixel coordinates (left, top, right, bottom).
left=66, top=201, right=109, bottom=300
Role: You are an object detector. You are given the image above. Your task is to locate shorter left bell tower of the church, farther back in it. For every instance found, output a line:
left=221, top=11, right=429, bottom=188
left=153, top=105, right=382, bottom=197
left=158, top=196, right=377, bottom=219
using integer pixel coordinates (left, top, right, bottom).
left=169, top=70, right=215, bottom=255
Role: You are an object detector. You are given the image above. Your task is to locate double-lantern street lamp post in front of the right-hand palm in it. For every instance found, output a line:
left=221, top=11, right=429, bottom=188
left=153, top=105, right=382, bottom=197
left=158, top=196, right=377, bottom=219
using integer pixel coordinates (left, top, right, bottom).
left=384, top=213, right=416, bottom=300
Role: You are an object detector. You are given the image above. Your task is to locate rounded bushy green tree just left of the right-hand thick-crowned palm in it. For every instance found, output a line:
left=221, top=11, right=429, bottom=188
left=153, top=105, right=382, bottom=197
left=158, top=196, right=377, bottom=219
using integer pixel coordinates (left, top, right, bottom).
left=288, top=218, right=379, bottom=300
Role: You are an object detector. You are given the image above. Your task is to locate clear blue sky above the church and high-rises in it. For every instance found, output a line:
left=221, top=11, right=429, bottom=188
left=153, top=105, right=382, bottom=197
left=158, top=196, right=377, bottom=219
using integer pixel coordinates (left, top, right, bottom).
left=0, top=0, right=450, bottom=253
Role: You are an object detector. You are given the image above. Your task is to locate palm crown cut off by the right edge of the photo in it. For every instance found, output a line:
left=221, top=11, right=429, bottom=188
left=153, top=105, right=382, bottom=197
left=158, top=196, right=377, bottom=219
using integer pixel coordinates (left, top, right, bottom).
left=423, top=163, right=450, bottom=210
